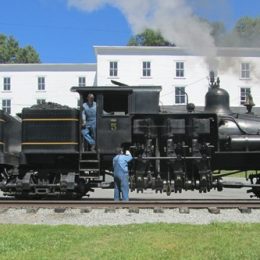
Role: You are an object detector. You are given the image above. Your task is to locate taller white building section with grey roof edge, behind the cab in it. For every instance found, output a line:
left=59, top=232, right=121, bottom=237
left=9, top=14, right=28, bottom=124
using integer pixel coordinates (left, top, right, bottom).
left=95, top=47, right=260, bottom=110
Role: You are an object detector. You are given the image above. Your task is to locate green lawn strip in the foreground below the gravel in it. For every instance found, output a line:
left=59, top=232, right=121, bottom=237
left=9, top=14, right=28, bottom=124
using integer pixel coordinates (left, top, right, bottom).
left=0, top=224, right=260, bottom=259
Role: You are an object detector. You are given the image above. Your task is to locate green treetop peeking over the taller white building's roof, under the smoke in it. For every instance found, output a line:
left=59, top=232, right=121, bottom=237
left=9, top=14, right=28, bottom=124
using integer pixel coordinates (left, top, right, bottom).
left=127, top=29, right=175, bottom=46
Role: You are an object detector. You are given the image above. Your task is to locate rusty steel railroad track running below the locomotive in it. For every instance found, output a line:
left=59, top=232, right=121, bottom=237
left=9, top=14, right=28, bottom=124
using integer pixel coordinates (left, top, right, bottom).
left=0, top=199, right=260, bottom=209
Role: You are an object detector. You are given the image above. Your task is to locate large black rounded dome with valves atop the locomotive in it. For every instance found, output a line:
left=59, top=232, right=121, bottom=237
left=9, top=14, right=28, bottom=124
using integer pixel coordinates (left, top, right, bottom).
left=205, top=71, right=231, bottom=114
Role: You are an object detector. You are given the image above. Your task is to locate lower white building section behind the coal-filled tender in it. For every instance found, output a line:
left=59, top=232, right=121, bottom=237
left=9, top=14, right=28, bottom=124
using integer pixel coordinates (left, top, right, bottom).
left=0, top=64, right=96, bottom=115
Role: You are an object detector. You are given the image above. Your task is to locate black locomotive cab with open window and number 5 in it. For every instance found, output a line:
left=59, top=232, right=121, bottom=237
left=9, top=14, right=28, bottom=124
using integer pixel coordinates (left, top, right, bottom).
left=72, top=86, right=161, bottom=155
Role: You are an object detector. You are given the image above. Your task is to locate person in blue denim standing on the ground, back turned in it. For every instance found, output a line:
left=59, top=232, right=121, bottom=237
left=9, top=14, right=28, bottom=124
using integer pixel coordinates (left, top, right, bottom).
left=113, top=149, right=133, bottom=201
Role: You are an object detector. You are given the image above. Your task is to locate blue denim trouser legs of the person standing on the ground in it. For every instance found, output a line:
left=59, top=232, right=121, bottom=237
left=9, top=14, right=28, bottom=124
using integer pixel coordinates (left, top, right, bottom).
left=114, top=173, right=129, bottom=201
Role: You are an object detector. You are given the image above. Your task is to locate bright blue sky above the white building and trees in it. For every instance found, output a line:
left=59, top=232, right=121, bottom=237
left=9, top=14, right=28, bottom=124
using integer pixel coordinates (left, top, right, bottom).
left=0, top=0, right=260, bottom=63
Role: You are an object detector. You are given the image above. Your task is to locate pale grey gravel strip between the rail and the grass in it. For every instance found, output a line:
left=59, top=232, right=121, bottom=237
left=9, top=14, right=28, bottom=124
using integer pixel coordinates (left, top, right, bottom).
left=0, top=208, right=260, bottom=226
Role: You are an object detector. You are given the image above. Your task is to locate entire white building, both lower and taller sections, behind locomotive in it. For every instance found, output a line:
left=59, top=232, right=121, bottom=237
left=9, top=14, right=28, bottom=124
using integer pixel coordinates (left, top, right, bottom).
left=0, top=46, right=260, bottom=114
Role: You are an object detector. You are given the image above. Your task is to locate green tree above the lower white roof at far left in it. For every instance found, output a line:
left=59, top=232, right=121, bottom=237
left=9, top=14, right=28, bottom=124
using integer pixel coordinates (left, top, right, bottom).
left=0, top=34, right=40, bottom=63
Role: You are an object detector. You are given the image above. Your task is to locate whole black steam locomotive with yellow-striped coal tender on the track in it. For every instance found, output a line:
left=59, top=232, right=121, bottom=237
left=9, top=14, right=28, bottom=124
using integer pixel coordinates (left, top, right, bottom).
left=0, top=73, right=260, bottom=198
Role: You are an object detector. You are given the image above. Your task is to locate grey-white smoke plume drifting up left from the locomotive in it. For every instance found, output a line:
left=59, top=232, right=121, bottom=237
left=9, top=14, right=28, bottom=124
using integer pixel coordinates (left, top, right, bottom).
left=68, top=0, right=223, bottom=69
